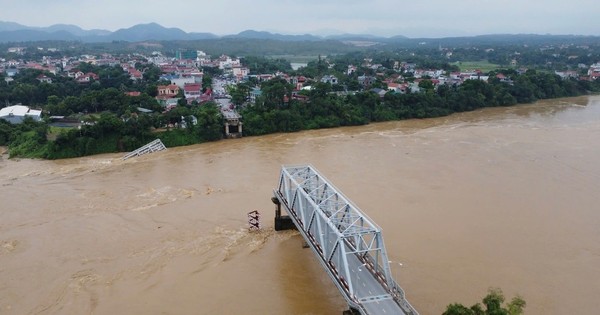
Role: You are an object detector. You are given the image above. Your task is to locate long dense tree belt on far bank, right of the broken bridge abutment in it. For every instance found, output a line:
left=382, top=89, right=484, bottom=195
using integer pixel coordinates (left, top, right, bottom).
left=242, top=70, right=598, bottom=135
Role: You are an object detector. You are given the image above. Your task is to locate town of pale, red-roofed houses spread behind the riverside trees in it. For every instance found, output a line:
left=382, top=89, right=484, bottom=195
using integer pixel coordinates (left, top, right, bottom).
left=0, top=42, right=600, bottom=136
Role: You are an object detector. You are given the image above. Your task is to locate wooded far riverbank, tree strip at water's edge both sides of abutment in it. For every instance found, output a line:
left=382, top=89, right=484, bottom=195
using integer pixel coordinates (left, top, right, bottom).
left=5, top=71, right=596, bottom=159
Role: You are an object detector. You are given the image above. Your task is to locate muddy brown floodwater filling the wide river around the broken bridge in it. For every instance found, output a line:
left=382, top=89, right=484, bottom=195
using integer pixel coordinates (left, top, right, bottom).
left=0, top=96, right=600, bottom=315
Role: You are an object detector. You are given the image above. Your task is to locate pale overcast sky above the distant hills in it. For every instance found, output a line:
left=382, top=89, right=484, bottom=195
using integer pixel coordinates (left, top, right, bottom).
left=0, top=0, right=600, bottom=37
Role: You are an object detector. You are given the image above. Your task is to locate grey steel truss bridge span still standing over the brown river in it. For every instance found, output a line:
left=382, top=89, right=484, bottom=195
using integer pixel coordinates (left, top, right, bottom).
left=273, top=165, right=418, bottom=315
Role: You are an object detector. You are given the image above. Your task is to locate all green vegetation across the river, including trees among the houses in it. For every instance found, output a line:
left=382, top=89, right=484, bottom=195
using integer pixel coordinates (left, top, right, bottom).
left=0, top=49, right=600, bottom=159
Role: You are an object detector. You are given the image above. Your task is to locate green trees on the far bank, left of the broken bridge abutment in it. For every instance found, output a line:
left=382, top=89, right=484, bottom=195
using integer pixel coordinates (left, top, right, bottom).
left=0, top=103, right=223, bottom=159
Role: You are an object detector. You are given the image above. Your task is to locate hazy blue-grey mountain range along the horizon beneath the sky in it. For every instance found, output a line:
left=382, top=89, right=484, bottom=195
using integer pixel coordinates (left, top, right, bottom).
left=0, top=21, right=598, bottom=47
